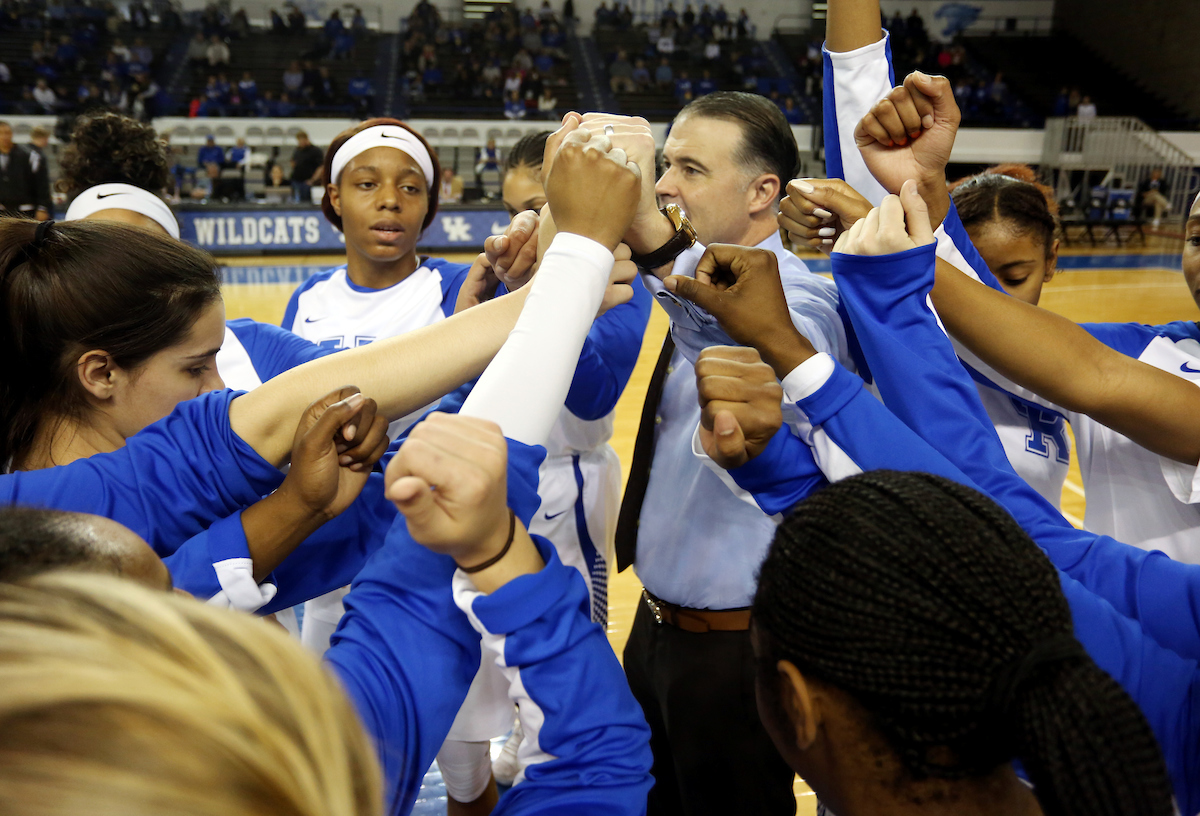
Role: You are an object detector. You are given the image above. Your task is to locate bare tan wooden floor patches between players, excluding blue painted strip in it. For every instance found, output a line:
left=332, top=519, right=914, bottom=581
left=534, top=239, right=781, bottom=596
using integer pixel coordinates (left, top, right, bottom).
left=224, top=242, right=1200, bottom=816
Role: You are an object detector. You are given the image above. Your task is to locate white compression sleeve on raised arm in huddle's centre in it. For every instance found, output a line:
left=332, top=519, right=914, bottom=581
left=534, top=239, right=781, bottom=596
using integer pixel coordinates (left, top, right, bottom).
left=460, top=233, right=613, bottom=445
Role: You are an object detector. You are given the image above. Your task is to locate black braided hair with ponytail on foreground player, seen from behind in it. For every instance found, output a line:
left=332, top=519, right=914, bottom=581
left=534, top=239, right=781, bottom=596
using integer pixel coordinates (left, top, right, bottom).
left=754, top=470, right=1174, bottom=816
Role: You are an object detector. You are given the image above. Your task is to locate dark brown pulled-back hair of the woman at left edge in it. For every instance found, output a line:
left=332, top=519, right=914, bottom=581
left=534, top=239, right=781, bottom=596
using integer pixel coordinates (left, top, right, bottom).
left=0, top=218, right=221, bottom=469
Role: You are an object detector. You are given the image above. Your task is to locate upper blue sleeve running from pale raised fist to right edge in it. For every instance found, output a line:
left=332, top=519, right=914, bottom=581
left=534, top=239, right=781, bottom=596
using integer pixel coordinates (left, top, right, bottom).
left=834, top=246, right=1200, bottom=659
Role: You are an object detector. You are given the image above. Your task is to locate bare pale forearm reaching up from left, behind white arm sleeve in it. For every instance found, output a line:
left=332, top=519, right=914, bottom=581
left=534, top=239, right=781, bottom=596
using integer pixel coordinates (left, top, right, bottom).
left=229, top=289, right=527, bottom=464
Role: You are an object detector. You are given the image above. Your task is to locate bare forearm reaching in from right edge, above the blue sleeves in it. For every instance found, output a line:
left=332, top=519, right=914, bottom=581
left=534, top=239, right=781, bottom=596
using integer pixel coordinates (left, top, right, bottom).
left=932, top=259, right=1200, bottom=464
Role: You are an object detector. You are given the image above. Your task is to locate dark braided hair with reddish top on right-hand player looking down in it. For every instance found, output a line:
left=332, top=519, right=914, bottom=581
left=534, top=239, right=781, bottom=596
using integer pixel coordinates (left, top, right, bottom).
left=950, top=164, right=1060, bottom=258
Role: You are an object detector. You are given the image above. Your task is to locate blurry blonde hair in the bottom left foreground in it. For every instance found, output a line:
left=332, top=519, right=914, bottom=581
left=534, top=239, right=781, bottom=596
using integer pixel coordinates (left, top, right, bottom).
left=0, top=572, right=383, bottom=816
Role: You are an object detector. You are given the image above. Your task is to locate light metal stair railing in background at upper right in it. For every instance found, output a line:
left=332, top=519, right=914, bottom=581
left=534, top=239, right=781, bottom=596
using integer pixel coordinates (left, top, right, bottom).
left=1042, top=116, right=1196, bottom=222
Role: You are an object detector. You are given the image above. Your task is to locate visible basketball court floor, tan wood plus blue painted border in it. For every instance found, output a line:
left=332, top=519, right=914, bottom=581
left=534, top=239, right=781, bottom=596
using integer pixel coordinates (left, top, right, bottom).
left=222, top=236, right=1200, bottom=816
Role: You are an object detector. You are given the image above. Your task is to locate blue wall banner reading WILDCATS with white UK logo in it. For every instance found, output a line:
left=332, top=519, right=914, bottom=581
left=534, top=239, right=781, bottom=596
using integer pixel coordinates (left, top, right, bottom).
left=176, top=208, right=509, bottom=254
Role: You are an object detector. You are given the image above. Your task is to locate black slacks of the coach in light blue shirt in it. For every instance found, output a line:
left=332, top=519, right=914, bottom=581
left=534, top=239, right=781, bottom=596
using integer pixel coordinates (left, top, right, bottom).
left=624, top=602, right=796, bottom=816
